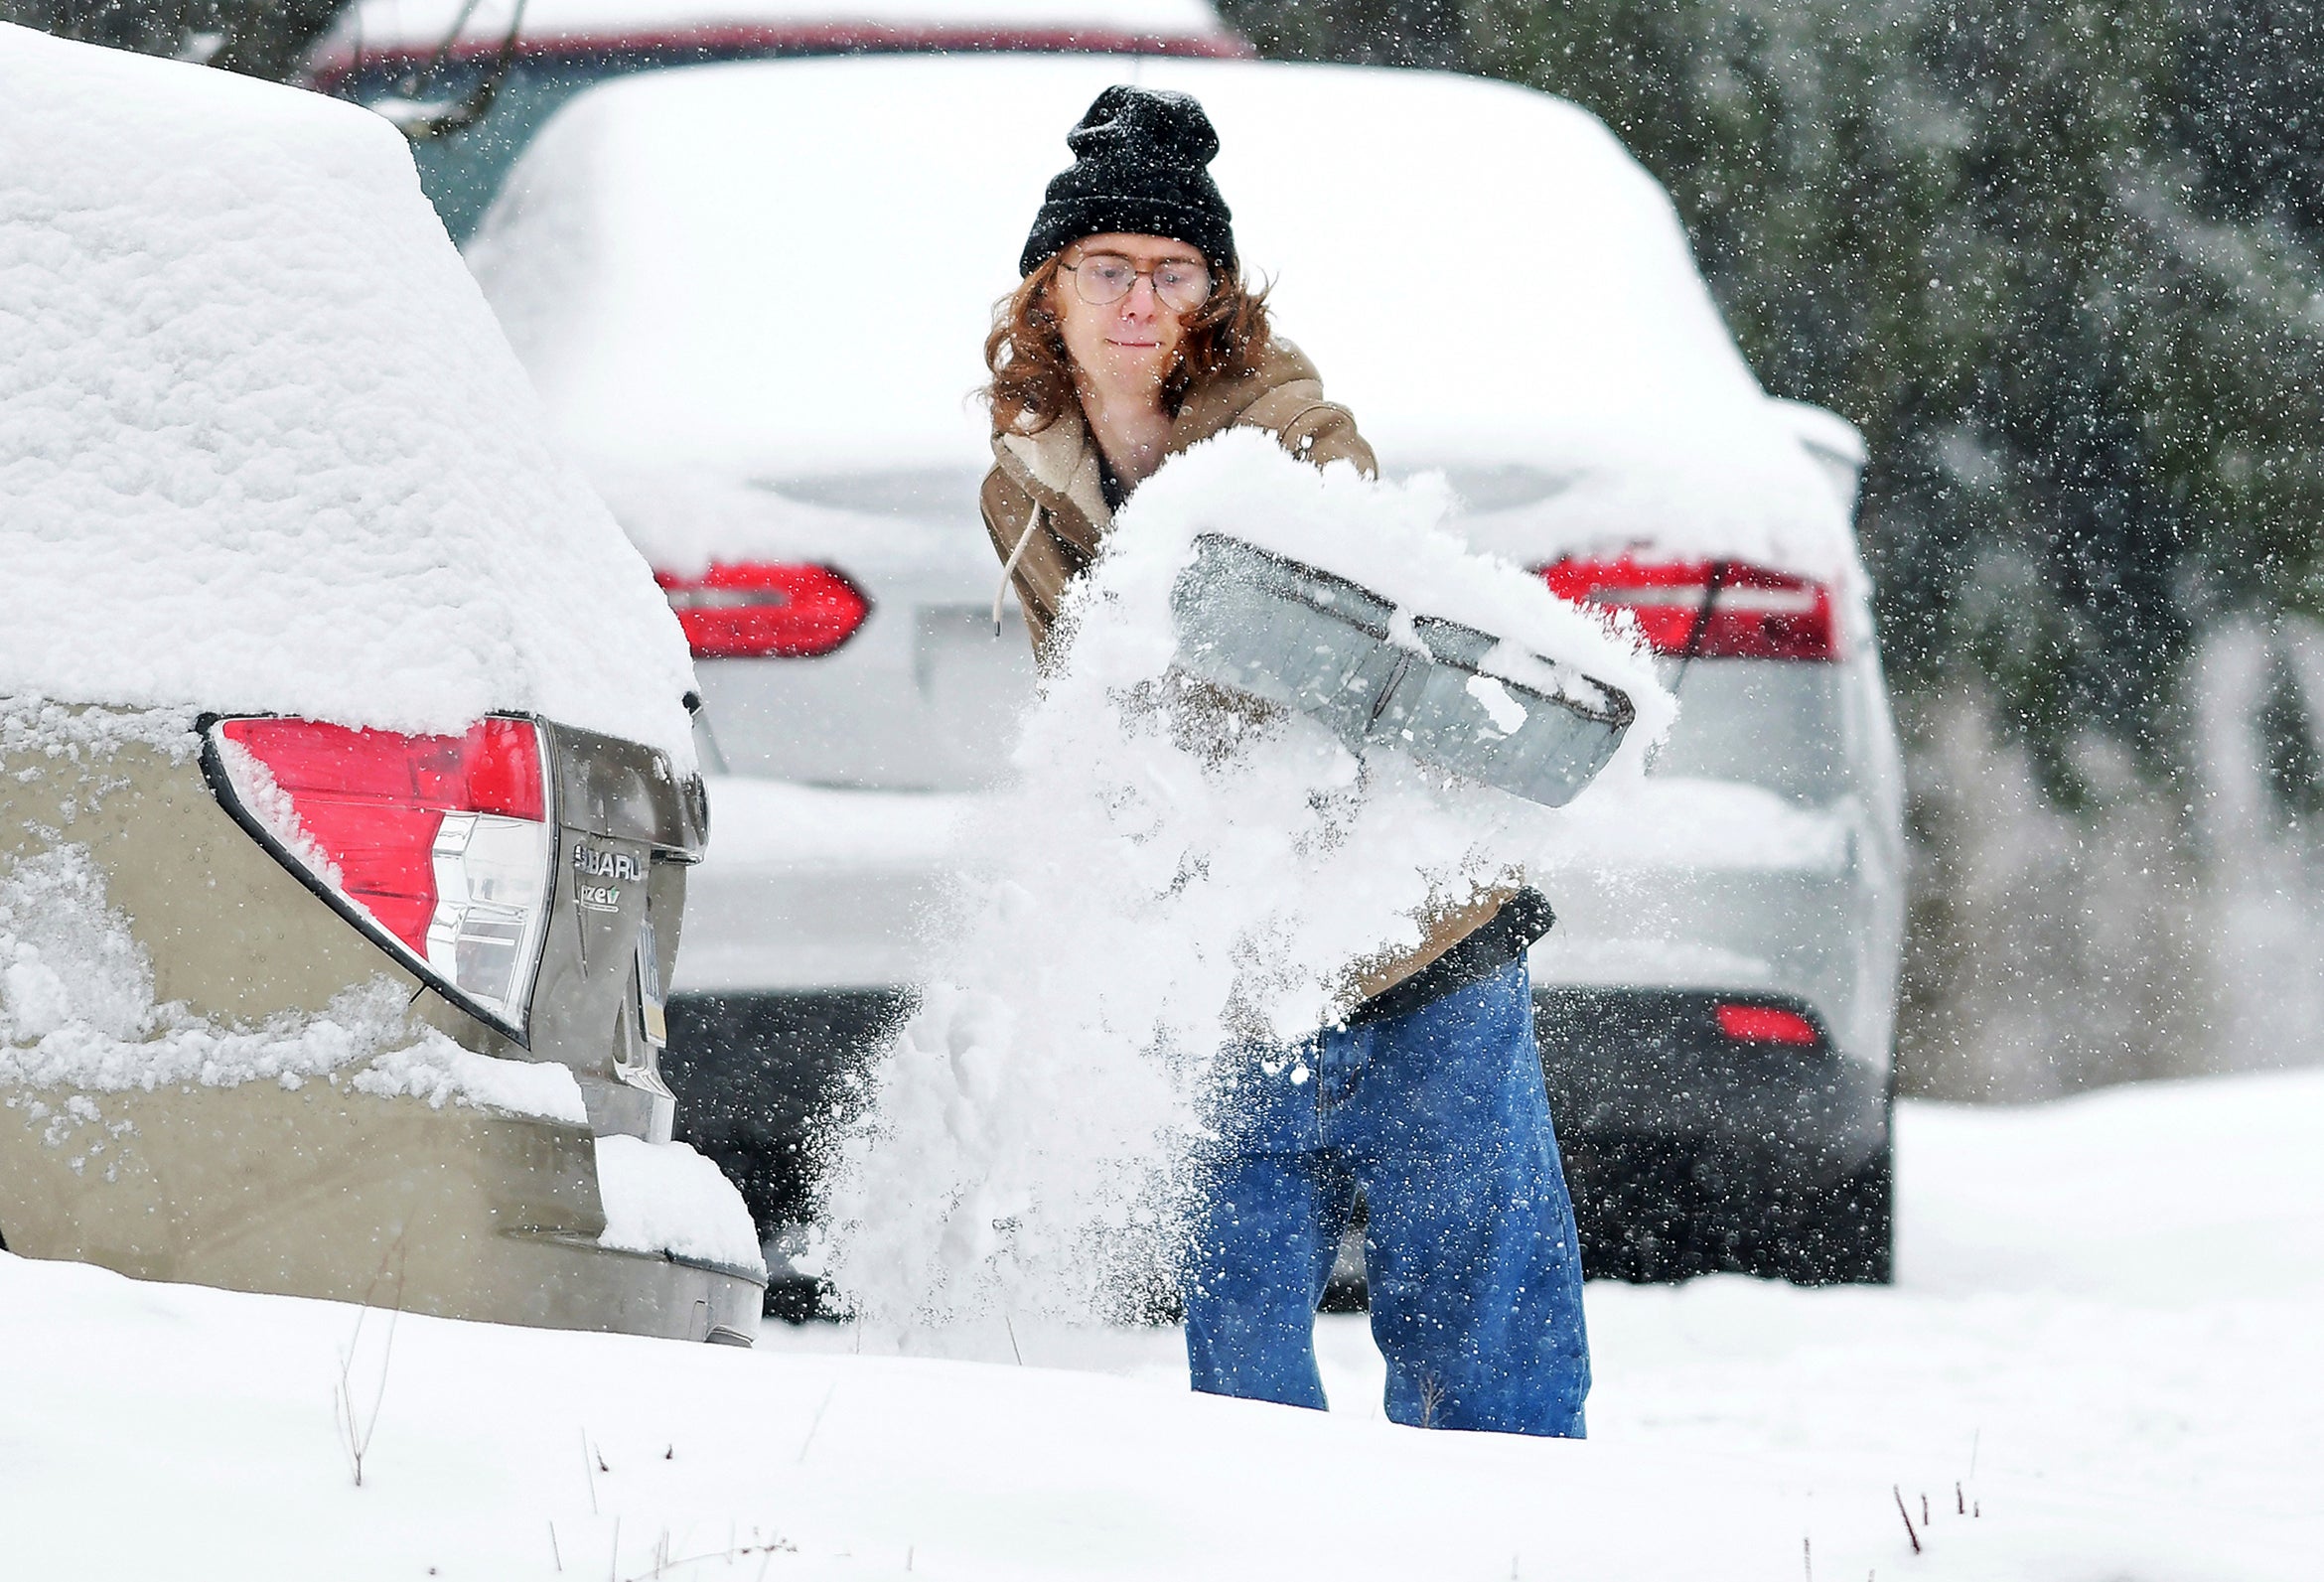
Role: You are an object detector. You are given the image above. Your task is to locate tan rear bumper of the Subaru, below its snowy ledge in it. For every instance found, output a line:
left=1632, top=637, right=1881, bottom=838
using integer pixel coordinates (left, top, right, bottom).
left=0, top=1080, right=765, bottom=1345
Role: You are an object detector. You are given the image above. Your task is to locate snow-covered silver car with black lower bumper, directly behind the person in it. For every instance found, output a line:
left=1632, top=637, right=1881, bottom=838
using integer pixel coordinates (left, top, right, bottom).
left=467, top=58, right=1903, bottom=1280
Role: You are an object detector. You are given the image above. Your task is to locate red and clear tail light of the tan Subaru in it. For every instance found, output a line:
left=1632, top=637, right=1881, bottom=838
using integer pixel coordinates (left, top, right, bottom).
left=205, top=715, right=553, bottom=1039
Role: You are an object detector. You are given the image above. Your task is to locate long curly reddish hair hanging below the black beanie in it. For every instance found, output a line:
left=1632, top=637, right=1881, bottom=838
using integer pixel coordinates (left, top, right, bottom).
left=983, top=251, right=1273, bottom=434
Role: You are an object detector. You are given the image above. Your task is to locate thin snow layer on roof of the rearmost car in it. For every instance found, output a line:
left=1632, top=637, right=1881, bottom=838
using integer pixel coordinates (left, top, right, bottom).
left=316, top=0, right=1236, bottom=58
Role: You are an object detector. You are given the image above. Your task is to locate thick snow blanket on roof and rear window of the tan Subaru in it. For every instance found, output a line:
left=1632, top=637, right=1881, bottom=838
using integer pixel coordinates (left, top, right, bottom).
left=0, top=26, right=692, bottom=765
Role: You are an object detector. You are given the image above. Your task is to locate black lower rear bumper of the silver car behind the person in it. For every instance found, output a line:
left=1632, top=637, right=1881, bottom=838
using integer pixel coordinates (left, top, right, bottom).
left=662, top=987, right=1889, bottom=1317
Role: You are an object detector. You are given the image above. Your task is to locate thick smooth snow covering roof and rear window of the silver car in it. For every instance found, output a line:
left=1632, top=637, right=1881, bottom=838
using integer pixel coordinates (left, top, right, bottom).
left=470, top=56, right=1854, bottom=590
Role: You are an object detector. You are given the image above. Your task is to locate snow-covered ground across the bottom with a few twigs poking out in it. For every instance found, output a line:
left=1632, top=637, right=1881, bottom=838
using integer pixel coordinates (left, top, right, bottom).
left=0, top=1074, right=2324, bottom=1582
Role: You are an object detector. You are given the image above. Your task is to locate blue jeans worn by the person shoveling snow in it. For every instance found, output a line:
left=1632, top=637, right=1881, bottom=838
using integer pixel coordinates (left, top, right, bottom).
left=1185, top=961, right=1590, bottom=1438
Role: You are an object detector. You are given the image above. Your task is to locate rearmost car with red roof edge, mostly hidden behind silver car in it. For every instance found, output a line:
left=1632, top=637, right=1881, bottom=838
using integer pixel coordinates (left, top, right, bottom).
left=305, top=0, right=1250, bottom=239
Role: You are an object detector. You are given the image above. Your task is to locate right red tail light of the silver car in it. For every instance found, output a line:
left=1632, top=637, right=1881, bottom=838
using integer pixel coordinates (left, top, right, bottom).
left=1540, top=555, right=1840, bottom=659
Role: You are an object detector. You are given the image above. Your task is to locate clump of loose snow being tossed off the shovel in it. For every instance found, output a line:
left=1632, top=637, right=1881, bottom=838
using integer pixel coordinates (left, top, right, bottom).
left=825, top=432, right=1673, bottom=1322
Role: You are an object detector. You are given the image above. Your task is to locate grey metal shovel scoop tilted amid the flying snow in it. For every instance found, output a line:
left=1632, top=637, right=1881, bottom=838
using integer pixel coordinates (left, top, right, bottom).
left=1169, top=532, right=1636, bottom=808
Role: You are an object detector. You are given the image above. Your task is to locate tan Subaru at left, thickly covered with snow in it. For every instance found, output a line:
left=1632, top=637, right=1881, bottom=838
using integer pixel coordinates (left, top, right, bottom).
left=0, top=26, right=765, bottom=1345
